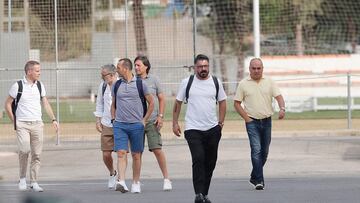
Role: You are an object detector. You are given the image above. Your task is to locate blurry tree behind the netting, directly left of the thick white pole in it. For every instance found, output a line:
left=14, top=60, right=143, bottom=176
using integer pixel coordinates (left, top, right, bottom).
left=199, top=0, right=249, bottom=90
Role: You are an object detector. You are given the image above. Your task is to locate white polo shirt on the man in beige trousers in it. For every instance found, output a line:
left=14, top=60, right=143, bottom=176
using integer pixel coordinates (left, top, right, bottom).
left=9, top=77, right=46, bottom=121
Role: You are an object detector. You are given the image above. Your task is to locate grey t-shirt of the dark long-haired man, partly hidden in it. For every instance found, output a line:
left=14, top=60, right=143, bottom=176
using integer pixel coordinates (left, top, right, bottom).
left=143, top=74, right=163, bottom=121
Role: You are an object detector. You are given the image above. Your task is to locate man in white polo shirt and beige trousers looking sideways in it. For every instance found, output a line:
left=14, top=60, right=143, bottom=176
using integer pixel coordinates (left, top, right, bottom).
left=5, top=61, right=59, bottom=192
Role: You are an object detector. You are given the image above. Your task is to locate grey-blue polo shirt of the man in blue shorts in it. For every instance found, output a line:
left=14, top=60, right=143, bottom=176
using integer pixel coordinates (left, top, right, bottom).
left=111, top=77, right=150, bottom=123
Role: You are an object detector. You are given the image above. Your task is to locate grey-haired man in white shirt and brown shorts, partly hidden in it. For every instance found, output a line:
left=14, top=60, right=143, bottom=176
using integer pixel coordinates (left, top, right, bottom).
left=94, top=64, right=117, bottom=189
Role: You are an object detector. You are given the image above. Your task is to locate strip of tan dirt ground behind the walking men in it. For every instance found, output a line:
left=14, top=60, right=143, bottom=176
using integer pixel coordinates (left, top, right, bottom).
left=0, top=119, right=360, bottom=142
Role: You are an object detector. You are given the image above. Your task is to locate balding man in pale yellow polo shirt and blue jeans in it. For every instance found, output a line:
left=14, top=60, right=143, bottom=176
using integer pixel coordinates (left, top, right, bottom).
left=234, top=58, right=285, bottom=190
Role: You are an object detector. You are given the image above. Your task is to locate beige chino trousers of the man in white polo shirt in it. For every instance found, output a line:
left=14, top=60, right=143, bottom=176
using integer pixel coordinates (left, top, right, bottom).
left=16, top=121, right=44, bottom=183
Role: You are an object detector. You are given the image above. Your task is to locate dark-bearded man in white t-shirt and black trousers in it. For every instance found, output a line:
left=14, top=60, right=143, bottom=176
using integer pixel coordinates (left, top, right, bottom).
left=173, top=54, right=227, bottom=203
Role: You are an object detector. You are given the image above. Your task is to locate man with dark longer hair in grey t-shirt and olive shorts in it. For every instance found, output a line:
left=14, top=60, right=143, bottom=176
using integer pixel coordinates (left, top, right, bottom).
left=134, top=56, right=172, bottom=191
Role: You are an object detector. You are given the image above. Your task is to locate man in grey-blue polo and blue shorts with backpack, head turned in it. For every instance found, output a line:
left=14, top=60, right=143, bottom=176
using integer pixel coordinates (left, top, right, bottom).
left=111, top=58, right=154, bottom=193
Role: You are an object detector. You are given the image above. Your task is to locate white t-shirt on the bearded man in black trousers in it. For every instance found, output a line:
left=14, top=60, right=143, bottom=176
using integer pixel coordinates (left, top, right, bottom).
left=176, top=76, right=227, bottom=131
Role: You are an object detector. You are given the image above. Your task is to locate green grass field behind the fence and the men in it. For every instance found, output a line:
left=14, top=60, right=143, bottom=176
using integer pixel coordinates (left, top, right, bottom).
left=0, top=98, right=360, bottom=123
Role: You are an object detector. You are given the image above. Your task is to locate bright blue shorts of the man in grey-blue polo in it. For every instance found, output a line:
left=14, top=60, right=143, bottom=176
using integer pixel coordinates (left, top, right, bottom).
left=113, top=121, right=144, bottom=153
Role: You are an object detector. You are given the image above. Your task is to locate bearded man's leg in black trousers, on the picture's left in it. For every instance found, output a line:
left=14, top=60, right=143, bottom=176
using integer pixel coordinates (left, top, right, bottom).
left=184, top=130, right=206, bottom=194
